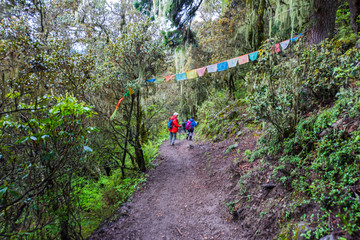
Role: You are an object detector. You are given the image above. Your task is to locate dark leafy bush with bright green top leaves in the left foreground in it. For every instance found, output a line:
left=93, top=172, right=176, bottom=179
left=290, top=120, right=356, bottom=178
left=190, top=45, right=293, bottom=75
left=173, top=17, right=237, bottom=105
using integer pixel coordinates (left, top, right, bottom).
left=0, top=96, right=96, bottom=238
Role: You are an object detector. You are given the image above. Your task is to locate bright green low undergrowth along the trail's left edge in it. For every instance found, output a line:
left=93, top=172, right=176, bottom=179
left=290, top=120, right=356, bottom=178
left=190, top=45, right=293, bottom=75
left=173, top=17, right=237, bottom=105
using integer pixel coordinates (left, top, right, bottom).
left=76, top=131, right=167, bottom=238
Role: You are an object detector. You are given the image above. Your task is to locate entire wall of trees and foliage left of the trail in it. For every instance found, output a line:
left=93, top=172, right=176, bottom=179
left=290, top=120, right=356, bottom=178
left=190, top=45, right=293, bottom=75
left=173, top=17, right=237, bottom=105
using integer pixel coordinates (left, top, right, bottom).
left=0, top=1, right=165, bottom=239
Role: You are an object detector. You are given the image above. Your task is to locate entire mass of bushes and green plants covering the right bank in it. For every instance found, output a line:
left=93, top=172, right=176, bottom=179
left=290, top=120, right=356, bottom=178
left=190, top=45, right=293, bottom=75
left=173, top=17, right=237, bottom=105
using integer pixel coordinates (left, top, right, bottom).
left=247, top=38, right=360, bottom=239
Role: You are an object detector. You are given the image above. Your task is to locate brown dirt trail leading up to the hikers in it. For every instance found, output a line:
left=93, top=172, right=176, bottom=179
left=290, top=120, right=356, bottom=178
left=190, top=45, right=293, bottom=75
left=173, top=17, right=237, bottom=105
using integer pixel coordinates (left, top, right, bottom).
left=90, top=140, right=245, bottom=240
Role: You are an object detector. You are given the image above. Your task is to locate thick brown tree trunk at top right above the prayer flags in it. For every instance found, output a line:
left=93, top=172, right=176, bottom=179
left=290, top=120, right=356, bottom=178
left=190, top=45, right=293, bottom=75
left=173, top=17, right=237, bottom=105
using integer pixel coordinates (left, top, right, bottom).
left=308, top=0, right=338, bottom=45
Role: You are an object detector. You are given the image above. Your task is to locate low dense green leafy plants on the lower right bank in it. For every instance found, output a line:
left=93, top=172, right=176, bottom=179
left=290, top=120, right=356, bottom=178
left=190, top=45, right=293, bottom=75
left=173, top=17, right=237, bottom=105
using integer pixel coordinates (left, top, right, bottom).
left=261, top=86, right=360, bottom=236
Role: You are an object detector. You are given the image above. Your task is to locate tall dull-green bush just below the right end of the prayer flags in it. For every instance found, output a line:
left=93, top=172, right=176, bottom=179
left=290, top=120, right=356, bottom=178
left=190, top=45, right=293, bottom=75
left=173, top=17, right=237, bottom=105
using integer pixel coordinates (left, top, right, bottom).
left=246, top=41, right=360, bottom=138
